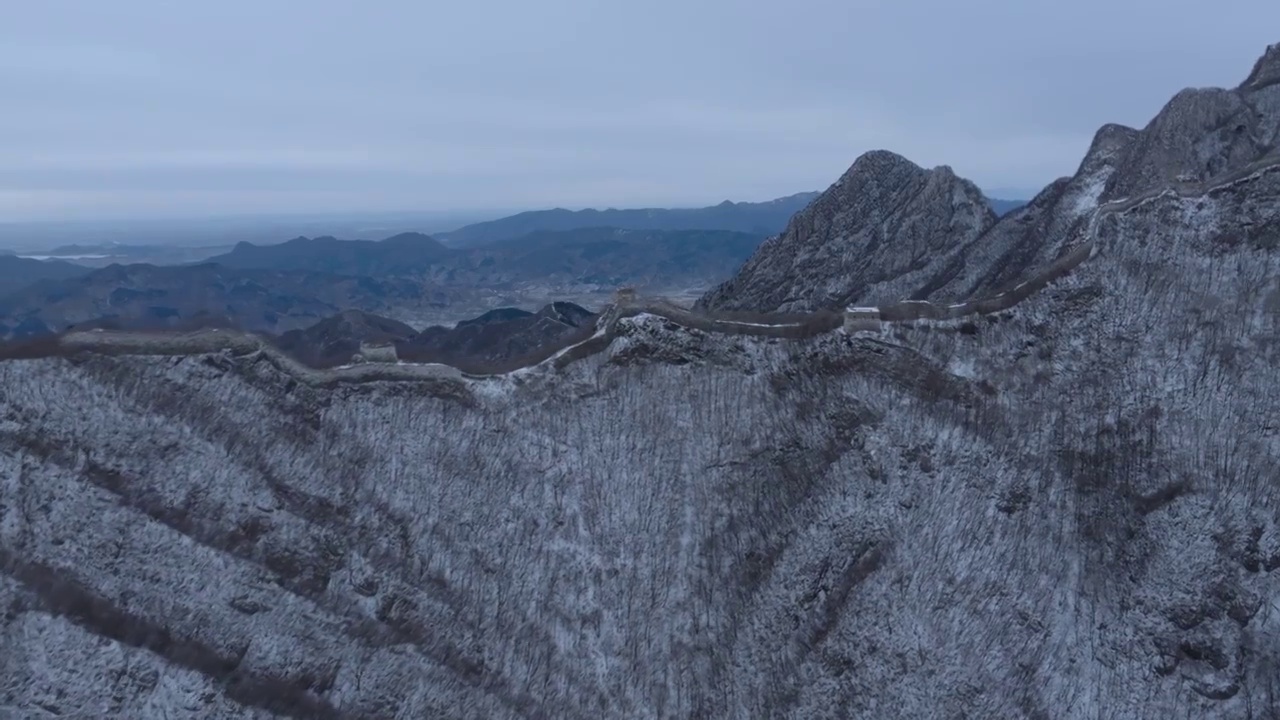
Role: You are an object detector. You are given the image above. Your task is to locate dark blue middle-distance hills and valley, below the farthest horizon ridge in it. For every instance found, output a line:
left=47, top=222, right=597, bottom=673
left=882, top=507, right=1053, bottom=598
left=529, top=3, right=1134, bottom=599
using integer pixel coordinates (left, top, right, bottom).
left=0, top=228, right=760, bottom=340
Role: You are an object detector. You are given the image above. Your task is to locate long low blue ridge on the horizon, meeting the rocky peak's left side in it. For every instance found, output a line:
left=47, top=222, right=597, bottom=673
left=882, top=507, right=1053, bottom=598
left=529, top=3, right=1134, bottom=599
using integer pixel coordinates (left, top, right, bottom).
left=435, top=192, right=818, bottom=247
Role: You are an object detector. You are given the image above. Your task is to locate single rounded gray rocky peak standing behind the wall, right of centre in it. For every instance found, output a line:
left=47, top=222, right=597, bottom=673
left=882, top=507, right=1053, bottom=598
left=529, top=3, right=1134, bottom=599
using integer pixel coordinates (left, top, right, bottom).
left=699, top=151, right=996, bottom=313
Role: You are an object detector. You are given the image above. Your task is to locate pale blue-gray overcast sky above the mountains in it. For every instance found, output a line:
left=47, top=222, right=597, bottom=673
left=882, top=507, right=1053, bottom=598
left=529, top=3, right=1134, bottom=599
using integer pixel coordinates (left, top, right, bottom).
left=0, top=0, right=1280, bottom=222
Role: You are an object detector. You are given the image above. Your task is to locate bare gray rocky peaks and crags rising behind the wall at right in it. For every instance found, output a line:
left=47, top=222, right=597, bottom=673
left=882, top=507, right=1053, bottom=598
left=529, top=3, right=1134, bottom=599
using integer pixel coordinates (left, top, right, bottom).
left=700, top=46, right=1280, bottom=311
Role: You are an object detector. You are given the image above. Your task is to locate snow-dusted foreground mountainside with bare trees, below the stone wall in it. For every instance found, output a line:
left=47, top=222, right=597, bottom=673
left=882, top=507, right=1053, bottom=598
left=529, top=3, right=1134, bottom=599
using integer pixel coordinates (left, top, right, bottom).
left=0, top=43, right=1280, bottom=720
